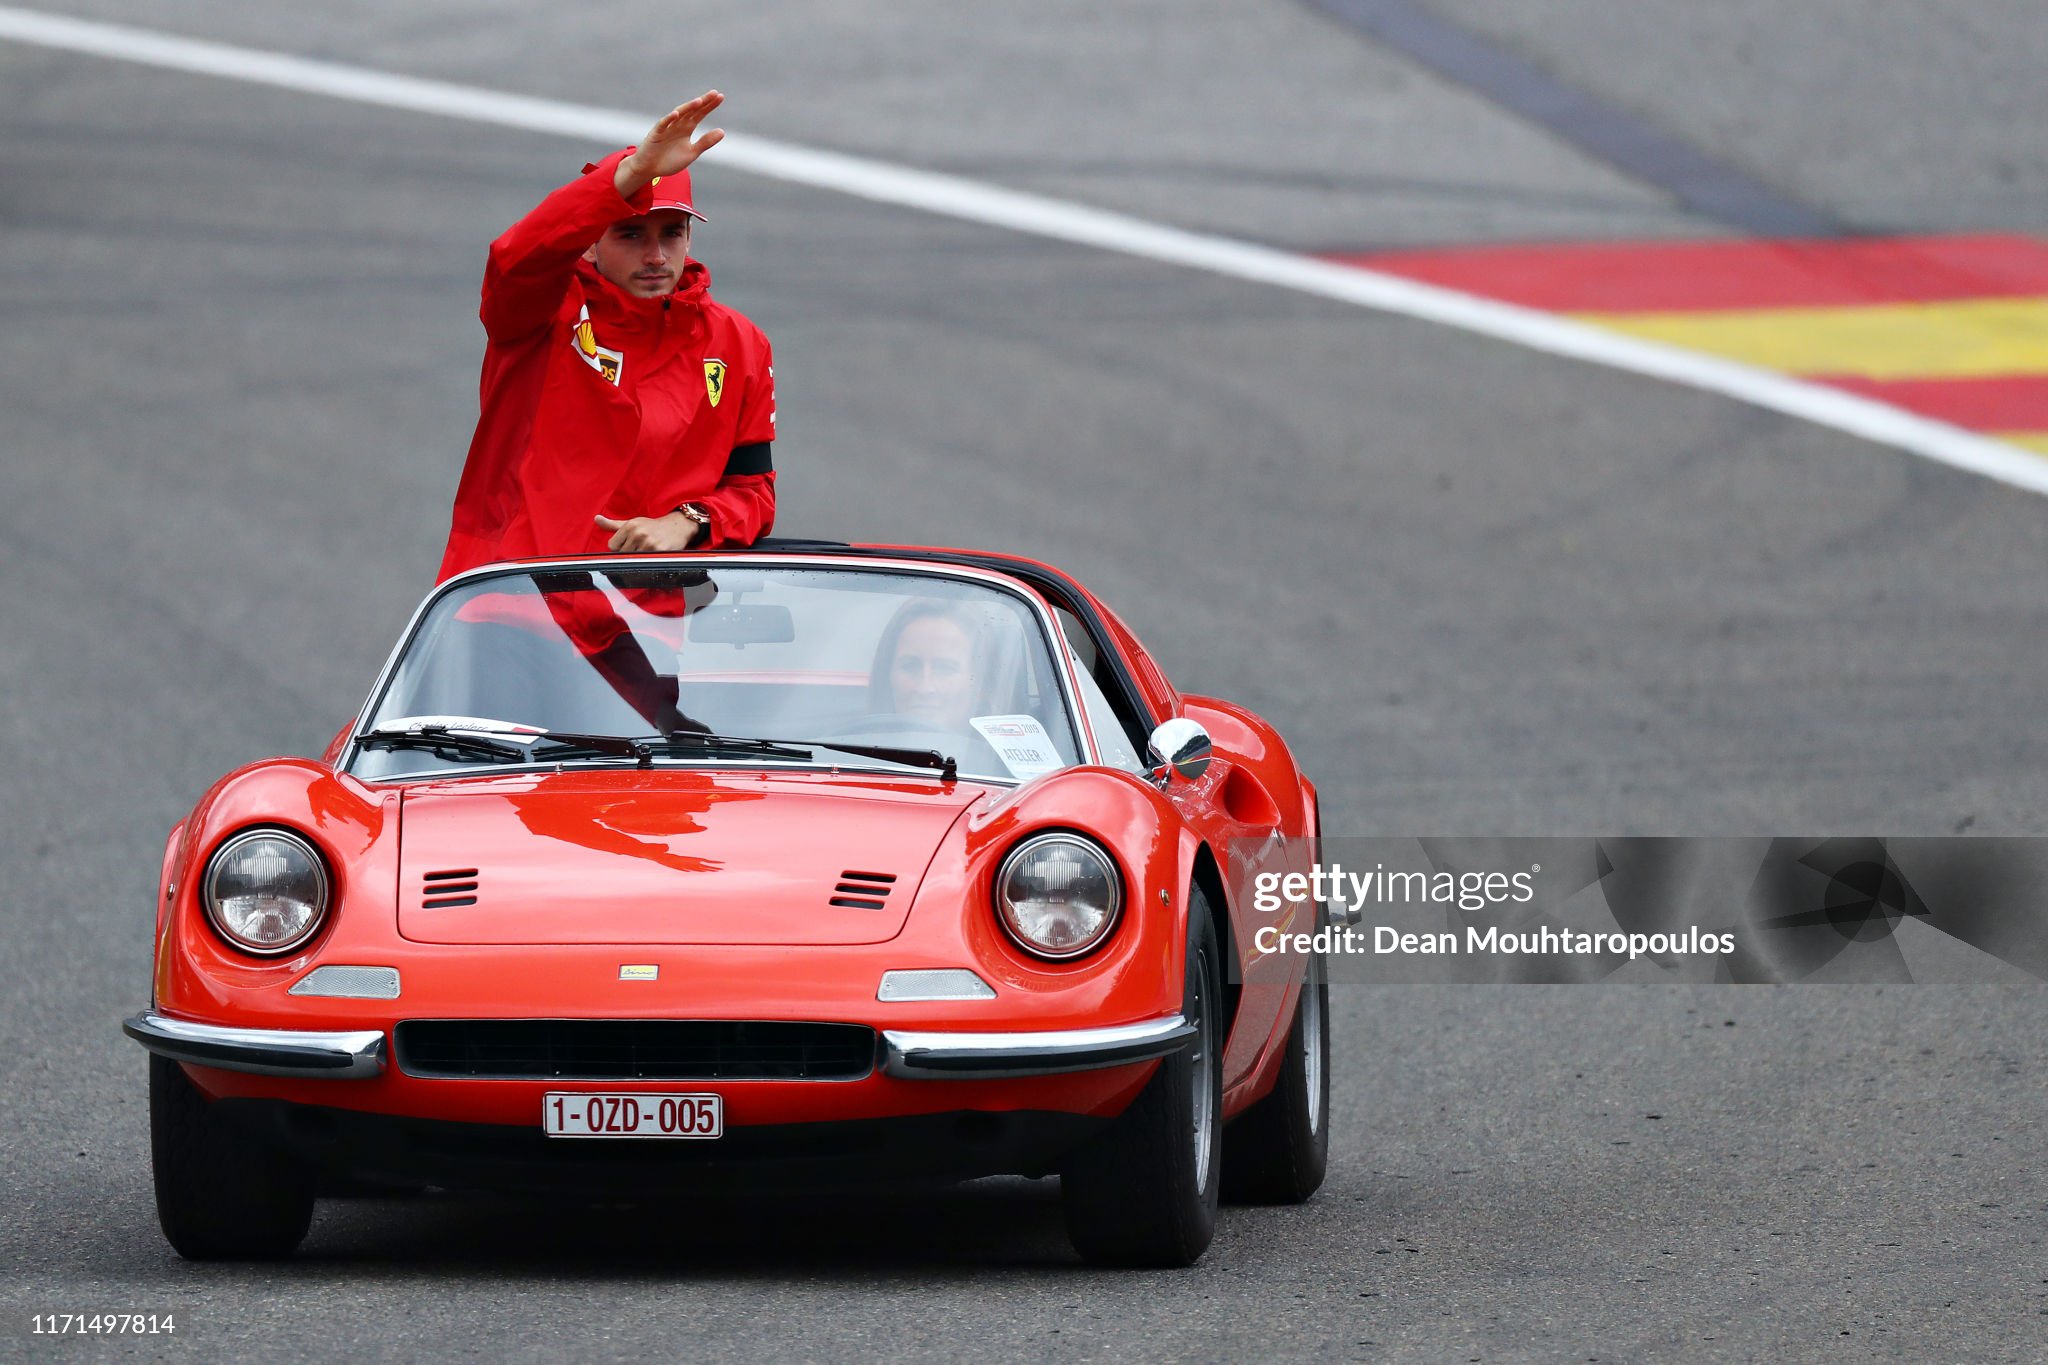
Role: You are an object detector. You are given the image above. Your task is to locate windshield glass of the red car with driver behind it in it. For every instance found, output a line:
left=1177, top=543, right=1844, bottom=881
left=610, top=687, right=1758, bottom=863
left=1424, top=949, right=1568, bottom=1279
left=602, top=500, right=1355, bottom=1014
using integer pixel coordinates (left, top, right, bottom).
left=350, top=565, right=1081, bottom=782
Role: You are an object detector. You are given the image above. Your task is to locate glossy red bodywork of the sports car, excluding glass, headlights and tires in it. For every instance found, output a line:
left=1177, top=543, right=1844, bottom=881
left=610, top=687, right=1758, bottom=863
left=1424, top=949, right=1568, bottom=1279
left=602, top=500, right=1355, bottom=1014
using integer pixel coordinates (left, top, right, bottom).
left=154, top=551, right=1319, bottom=1178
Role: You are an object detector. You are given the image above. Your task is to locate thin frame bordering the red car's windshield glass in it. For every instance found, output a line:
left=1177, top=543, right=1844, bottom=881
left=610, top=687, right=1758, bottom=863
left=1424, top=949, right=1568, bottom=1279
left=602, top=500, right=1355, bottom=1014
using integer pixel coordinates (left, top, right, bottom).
left=334, top=551, right=1102, bottom=786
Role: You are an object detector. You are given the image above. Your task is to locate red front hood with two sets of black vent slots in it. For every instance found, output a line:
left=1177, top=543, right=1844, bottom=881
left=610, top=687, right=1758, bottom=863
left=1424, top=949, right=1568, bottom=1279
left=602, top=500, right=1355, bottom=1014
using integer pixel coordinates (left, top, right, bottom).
left=397, top=769, right=985, bottom=945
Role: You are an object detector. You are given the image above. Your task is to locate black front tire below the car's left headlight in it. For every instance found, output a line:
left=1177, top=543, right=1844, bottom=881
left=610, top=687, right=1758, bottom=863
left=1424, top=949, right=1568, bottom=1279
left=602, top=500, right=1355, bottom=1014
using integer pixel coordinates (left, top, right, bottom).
left=150, top=1054, right=313, bottom=1261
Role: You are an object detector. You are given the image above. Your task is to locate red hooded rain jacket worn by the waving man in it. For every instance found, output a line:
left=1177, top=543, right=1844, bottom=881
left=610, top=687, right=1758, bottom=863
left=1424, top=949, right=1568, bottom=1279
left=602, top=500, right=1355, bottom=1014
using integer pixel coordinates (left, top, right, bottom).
left=440, top=151, right=774, bottom=579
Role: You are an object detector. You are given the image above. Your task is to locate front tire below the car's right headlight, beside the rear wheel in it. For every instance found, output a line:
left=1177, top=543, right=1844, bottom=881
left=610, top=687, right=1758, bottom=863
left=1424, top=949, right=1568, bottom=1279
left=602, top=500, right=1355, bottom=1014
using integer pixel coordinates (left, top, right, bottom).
left=1059, top=890, right=1225, bottom=1267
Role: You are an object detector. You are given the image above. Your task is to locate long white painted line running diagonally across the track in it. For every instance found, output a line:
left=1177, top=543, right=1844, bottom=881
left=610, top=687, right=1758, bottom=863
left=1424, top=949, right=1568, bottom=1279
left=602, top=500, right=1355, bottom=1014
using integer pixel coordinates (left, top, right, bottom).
left=0, top=6, right=2048, bottom=493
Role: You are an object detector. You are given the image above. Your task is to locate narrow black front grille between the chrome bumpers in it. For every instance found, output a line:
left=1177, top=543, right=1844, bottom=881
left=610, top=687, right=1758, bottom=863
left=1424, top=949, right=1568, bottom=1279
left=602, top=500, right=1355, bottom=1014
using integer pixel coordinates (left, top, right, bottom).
left=395, top=1019, right=874, bottom=1081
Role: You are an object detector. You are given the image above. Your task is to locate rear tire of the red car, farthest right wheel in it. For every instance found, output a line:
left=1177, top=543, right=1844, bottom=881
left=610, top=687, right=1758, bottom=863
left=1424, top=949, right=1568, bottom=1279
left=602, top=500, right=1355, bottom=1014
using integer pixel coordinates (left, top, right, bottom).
left=1223, top=954, right=1329, bottom=1203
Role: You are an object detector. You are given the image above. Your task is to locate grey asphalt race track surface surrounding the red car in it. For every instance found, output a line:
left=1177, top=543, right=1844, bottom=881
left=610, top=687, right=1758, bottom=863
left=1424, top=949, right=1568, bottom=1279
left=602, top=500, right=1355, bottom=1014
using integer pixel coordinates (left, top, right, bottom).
left=0, top=0, right=2048, bottom=1361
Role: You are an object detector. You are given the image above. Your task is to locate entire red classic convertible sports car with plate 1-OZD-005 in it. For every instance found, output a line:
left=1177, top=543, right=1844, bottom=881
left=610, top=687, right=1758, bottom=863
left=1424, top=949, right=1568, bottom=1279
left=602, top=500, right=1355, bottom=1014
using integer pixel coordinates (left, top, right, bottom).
left=125, top=542, right=1329, bottom=1265
